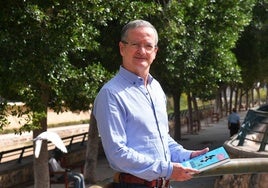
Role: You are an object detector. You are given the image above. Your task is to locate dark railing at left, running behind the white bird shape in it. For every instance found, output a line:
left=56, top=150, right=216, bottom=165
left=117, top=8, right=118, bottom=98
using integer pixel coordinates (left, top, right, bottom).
left=0, top=132, right=88, bottom=164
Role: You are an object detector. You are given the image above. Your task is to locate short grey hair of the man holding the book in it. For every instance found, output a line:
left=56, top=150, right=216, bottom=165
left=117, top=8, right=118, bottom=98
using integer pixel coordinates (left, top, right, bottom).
left=121, top=20, right=158, bottom=45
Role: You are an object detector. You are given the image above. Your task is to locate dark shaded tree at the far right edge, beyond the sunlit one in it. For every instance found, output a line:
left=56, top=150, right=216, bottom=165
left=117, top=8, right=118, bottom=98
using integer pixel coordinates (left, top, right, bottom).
left=233, top=0, right=268, bottom=108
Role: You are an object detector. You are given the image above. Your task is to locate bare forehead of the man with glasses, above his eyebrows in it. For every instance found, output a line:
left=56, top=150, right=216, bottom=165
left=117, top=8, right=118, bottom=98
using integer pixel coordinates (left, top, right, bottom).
left=127, top=27, right=156, bottom=41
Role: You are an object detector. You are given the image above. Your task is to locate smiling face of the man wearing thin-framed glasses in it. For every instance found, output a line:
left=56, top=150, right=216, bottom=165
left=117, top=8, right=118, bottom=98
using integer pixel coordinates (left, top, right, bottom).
left=119, top=27, right=158, bottom=76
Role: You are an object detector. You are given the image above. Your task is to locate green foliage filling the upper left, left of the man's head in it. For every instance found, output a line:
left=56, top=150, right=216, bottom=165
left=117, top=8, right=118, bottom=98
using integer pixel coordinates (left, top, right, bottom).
left=0, top=0, right=161, bottom=130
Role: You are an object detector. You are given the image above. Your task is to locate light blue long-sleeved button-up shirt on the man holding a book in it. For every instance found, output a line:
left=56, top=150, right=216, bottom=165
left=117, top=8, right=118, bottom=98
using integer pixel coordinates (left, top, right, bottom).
left=93, top=67, right=192, bottom=181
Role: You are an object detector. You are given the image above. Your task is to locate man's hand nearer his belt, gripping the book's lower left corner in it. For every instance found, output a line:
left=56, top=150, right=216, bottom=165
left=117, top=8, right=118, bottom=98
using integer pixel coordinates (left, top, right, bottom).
left=170, top=163, right=199, bottom=181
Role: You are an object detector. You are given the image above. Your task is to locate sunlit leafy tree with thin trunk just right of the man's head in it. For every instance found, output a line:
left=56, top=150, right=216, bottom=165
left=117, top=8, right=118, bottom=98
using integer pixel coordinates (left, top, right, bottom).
left=153, top=0, right=255, bottom=140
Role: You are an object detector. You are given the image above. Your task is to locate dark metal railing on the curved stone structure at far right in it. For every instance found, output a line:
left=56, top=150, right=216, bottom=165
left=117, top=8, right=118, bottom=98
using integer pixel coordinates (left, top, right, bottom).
left=237, top=105, right=268, bottom=151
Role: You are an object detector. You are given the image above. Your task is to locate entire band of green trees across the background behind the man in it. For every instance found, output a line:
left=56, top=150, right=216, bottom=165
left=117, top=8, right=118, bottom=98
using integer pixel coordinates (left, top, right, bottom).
left=0, top=0, right=268, bottom=187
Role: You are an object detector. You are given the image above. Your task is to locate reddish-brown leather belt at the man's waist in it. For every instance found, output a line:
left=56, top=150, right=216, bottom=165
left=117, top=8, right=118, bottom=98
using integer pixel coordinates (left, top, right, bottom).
left=114, top=172, right=169, bottom=188
